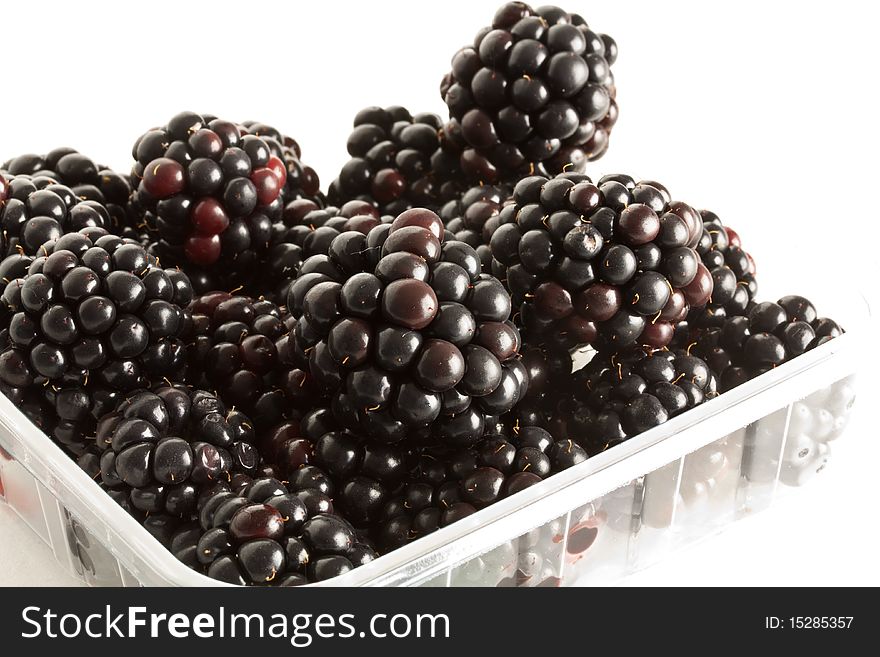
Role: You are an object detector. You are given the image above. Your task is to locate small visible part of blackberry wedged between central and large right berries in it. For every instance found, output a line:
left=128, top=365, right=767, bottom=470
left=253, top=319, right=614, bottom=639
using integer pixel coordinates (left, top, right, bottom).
left=438, top=185, right=513, bottom=272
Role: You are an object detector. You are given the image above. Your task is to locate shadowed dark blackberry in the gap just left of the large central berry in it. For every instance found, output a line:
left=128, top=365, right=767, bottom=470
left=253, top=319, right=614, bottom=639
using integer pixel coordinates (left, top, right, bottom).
left=188, top=292, right=313, bottom=422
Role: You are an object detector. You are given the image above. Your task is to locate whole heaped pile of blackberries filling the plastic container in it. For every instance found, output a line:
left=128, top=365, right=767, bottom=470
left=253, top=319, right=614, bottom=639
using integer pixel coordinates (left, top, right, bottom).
left=0, top=2, right=851, bottom=586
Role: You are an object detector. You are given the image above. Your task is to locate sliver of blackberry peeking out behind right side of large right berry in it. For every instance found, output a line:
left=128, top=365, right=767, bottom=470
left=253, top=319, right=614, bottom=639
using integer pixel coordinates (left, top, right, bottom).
left=688, top=210, right=758, bottom=328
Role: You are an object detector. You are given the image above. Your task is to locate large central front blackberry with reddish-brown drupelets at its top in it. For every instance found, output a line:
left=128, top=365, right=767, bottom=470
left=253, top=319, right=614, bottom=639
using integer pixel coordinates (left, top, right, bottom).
left=287, top=209, right=527, bottom=445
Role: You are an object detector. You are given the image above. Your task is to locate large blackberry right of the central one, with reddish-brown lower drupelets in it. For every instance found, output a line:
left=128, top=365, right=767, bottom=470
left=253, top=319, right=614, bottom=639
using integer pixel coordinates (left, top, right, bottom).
left=490, top=173, right=713, bottom=351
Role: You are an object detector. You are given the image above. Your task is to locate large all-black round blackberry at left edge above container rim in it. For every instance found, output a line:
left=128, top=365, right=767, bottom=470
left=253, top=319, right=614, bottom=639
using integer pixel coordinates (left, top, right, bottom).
left=0, top=228, right=192, bottom=450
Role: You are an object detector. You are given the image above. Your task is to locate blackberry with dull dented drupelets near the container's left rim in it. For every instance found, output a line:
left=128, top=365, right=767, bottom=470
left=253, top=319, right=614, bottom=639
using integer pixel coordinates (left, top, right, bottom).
left=95, top=385, right=258, bottom=518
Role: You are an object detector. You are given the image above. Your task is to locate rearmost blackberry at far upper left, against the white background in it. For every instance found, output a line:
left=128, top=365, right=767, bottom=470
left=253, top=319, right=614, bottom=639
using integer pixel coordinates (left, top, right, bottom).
left=0, top=147, right=143, bottom=241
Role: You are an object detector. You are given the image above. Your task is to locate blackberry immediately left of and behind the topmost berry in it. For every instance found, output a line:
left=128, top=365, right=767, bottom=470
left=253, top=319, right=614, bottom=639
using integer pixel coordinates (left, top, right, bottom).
left=329, top=107, right=461, bottom=215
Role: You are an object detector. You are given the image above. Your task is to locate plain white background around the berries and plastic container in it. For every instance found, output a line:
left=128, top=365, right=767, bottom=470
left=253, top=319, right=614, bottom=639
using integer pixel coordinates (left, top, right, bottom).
left=0, top=0, right=880, bottom=585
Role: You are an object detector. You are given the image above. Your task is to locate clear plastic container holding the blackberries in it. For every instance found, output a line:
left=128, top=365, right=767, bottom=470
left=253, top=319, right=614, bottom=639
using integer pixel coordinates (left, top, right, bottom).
left=0, top=280, right=872, bottom=586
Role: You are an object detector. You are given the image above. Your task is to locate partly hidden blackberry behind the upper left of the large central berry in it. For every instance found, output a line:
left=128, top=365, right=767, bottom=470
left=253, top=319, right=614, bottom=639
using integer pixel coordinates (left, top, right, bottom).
left=262, top=199, right=384, bottom=305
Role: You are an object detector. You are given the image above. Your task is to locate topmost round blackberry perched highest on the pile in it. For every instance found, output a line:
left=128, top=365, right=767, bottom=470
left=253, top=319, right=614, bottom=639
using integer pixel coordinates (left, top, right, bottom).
left=440, top=2, right=617, bottom=182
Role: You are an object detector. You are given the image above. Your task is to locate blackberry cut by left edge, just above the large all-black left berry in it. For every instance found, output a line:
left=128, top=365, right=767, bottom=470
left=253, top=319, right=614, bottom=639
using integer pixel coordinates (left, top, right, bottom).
left=0, top=165, right=118, bottom=257
